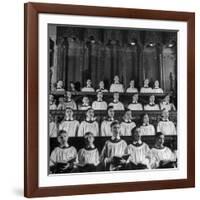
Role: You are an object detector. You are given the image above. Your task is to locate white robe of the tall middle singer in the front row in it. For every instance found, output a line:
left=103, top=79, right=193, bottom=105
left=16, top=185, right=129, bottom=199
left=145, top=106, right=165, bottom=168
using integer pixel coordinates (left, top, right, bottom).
left=101, top=139, right=127, bottom=164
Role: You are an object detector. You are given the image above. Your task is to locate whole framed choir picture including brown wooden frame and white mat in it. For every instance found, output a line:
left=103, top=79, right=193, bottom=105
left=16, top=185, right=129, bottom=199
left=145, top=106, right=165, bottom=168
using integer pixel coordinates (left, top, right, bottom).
left=24, top=3, right=195, bottom=197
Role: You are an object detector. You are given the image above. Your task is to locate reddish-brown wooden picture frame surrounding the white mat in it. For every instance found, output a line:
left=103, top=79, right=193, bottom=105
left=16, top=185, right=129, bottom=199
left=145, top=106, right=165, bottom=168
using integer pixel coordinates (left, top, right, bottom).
left=24, top=3, right=195, bottom=197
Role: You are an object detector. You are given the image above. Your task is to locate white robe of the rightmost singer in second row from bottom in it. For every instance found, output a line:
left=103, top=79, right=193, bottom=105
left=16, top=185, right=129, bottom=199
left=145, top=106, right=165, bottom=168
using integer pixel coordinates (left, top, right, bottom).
left=157, top=120, right=176, bottom=135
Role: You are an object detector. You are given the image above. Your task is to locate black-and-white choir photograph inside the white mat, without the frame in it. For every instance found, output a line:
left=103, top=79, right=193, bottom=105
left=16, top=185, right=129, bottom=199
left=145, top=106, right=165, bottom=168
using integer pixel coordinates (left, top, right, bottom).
left=47, top=24, right=178, bottom=175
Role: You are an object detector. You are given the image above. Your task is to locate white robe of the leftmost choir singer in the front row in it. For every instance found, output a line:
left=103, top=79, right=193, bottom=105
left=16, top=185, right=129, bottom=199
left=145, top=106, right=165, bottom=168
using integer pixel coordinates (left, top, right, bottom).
left=49, top=146, right=77, bottom=166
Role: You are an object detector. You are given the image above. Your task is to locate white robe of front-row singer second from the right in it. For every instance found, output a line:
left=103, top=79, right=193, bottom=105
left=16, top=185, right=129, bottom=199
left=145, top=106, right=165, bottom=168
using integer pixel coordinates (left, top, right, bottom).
left=127, top=141, right=150, bottom=168
